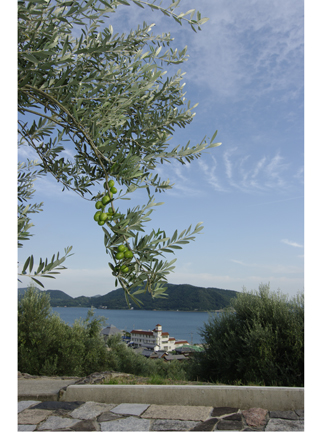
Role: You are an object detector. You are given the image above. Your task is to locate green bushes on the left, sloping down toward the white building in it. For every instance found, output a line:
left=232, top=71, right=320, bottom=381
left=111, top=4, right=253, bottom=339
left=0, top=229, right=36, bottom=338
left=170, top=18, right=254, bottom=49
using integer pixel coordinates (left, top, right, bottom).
left=18, top=287, right=190, bottom=379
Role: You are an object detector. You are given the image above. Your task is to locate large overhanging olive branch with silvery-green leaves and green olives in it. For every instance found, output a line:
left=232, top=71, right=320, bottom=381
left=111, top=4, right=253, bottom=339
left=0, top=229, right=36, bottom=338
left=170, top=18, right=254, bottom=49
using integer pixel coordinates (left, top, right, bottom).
left=18, top=0, right=219, bottom=304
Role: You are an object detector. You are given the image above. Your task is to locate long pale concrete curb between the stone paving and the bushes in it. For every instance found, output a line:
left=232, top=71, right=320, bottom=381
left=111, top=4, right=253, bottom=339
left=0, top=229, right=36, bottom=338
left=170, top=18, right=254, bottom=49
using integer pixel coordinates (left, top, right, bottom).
left=60, top=384, right=304, bottom=411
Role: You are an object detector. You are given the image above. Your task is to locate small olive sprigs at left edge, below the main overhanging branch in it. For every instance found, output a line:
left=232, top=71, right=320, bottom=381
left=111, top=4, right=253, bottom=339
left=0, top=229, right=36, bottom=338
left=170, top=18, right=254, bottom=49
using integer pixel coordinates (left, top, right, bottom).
left=17, top=161, right=72, bottom=287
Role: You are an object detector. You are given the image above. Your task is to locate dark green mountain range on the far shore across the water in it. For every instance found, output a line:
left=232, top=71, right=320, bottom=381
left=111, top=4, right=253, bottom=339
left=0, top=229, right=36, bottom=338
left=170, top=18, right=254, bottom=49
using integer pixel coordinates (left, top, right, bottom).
left=18, top=284, right=237, bottom=311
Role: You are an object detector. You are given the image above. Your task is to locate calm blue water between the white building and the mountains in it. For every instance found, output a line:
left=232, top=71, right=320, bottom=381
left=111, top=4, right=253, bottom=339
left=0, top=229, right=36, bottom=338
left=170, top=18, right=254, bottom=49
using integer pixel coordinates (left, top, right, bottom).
left=53, top=307, right=219, bottom=343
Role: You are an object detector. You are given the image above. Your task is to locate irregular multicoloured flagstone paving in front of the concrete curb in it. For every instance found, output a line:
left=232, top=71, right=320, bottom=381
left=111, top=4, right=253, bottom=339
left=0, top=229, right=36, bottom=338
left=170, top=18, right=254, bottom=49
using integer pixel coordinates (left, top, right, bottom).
left=18, top=400, right=304, bottom=431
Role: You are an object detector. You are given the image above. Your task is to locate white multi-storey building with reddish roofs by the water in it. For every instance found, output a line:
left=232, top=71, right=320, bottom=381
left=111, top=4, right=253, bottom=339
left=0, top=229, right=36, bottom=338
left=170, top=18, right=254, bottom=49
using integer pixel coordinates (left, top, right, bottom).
left=130, top=324, right=189, bottom=351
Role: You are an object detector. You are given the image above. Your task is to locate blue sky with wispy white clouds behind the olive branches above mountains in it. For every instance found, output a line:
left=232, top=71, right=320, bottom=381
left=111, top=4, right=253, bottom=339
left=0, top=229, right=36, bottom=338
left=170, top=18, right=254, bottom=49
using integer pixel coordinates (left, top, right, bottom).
left=18, top=0, right=304, bottom=297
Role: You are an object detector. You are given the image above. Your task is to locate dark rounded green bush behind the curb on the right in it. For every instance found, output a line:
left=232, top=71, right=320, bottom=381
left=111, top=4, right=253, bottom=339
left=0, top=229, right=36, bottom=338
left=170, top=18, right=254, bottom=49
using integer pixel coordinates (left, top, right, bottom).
left=191, top=285, right=304, bottom=386
